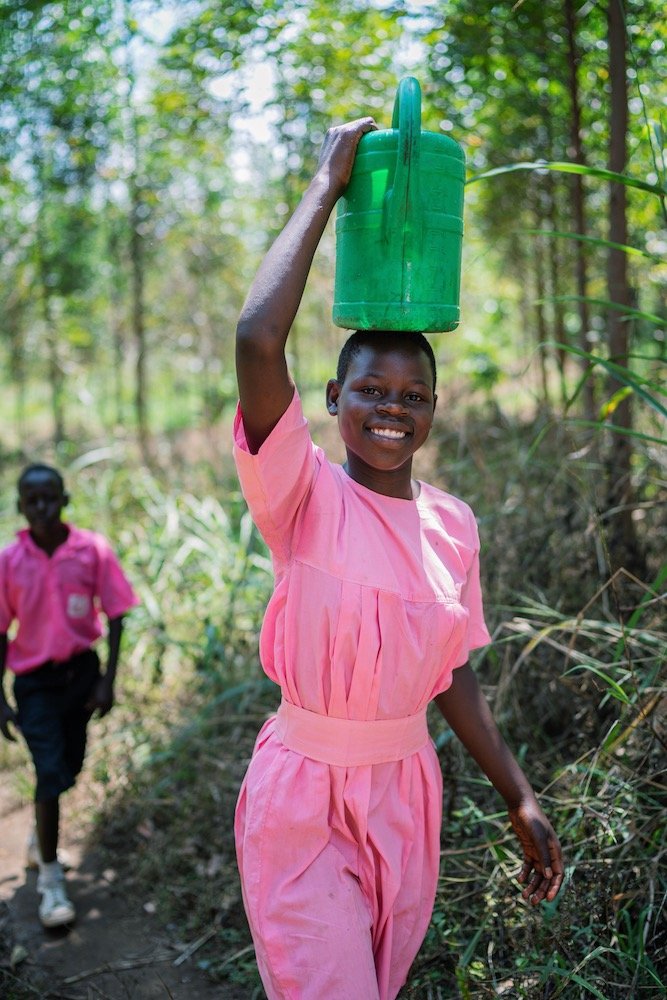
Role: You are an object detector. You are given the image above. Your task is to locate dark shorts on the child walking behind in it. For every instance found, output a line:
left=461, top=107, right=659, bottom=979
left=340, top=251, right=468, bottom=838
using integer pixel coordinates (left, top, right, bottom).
left=14, top=649, right=100, bottom=802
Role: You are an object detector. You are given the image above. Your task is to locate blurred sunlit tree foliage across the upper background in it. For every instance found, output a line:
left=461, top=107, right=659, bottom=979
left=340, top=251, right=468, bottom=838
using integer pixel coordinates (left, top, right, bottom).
left=0, top=0, right=665, bottom=447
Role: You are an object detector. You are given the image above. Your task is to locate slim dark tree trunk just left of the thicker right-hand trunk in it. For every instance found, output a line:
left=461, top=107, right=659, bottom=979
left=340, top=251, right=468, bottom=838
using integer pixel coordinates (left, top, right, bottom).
left=564, top=0, right=595, bottom=420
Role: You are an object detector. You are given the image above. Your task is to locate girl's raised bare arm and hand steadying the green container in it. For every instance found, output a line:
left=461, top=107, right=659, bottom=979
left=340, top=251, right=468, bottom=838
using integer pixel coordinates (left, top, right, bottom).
left=236, top=118, right=376, bottom=453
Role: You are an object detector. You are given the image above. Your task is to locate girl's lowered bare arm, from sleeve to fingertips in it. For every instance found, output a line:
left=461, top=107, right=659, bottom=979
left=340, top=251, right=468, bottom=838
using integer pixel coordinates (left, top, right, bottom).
left=435, top=663, right=563, bottom=905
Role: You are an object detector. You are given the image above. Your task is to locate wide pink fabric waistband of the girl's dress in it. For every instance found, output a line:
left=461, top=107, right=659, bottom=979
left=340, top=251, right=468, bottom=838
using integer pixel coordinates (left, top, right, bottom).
left=275, top=701, right=429, bottom=767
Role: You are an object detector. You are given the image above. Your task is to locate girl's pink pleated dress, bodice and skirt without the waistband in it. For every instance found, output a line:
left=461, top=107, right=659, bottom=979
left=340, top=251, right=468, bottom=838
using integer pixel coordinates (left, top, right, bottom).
left=234, top=393, right=489, bottom=1000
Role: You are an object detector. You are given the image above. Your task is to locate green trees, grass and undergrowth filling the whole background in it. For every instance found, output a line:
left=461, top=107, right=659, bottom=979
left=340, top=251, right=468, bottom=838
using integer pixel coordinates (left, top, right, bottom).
left=0, top=0, right=667, bottom=1000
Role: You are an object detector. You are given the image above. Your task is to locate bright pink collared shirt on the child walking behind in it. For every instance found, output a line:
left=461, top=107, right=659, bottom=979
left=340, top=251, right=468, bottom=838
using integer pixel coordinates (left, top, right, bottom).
left=0, top=524, right=139, bottom=674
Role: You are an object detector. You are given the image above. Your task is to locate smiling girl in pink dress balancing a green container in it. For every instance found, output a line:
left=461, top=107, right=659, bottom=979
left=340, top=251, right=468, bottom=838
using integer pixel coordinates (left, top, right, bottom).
left=234, top=118, right=563, bottom=1000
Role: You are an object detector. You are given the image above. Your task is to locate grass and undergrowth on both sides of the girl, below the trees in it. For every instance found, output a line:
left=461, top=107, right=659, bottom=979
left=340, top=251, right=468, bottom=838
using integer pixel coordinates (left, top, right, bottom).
left=0, top=407, right=667, bottom=1000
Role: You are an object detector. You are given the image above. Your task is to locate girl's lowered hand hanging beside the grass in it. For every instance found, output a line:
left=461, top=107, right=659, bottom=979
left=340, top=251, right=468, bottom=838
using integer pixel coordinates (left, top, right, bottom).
left=509, top=798, right=563, bottom=906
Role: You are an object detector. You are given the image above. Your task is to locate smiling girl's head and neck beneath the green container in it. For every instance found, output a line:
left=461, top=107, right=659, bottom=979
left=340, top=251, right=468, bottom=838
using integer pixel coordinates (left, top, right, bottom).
left=327, top=336, right=437, bottom=499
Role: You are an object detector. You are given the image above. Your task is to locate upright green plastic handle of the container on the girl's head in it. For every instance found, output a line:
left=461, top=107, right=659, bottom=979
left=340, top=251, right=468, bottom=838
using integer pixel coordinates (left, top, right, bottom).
left=383, top=76, right=422, bottom=245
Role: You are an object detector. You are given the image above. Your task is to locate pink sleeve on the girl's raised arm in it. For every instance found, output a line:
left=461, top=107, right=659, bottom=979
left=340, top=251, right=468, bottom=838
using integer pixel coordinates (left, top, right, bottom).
left=234, top=389, right=319, bottom=560
